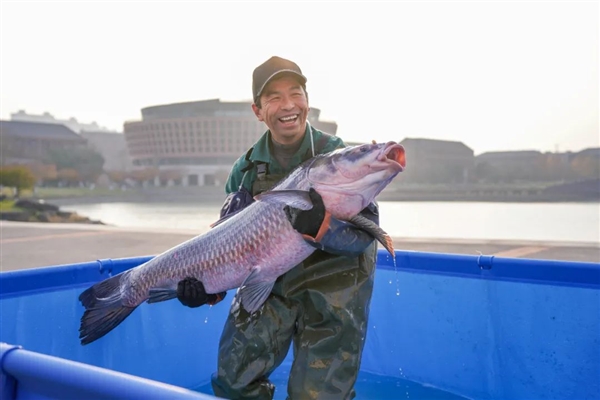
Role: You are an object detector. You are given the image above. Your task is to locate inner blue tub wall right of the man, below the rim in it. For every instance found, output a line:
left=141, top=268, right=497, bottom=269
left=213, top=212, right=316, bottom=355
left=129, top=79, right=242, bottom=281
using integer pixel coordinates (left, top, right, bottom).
left=363, top=255, right=600, bottom=399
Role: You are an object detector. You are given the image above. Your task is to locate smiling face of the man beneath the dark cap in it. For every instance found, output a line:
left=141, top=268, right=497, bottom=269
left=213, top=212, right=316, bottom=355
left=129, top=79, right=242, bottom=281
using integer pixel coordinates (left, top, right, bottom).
left=252, top=74, right=310, bottom=144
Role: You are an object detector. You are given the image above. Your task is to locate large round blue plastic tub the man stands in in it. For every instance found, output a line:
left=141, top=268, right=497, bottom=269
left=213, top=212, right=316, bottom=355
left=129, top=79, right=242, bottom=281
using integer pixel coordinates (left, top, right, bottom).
left=0, top=251, right=600, bottom=400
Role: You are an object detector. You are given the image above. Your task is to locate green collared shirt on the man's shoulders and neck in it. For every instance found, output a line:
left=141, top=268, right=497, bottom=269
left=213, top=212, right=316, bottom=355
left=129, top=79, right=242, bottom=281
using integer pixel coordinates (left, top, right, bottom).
left=225, top=123, right=346, bottom=194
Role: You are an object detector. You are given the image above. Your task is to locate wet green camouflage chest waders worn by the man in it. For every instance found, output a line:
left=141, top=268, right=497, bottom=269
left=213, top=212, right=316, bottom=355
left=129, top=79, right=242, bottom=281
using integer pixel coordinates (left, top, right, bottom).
left=212, top=159, right=377, bottom=400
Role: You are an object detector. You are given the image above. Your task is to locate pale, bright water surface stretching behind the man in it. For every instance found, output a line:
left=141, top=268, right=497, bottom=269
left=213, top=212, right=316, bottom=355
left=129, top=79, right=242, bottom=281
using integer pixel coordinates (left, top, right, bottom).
left=63, top=201, right=600, bottom=243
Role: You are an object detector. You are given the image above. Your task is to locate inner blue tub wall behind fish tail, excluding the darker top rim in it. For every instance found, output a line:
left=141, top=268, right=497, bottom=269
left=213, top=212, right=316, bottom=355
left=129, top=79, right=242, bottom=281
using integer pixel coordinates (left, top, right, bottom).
left=0, top=288, right=233, bottom=388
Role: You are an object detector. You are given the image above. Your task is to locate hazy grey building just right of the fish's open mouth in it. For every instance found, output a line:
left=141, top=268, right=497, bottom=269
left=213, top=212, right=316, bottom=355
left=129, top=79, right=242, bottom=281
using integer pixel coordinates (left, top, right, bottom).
left=400, top=138, right=474, bottom=183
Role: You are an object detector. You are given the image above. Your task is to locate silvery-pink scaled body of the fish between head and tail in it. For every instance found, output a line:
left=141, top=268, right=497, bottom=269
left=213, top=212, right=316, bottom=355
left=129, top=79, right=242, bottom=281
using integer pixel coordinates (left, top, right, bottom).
left=123, top=203, right=314, bottom=305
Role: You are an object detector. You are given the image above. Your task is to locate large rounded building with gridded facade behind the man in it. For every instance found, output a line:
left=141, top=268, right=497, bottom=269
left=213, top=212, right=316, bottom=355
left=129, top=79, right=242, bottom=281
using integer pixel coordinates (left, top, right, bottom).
left=124, top=99, right=337, bottom=186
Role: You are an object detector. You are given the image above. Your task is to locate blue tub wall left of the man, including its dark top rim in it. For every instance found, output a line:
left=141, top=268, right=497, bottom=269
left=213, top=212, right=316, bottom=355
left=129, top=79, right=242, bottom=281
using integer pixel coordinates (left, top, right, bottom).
left=0, top=257, right=227, bottom=388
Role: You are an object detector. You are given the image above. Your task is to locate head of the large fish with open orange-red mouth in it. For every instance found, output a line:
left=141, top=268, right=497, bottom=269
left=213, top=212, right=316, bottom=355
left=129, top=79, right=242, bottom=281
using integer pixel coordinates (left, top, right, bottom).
left=307, top=141, right=406, bottom=219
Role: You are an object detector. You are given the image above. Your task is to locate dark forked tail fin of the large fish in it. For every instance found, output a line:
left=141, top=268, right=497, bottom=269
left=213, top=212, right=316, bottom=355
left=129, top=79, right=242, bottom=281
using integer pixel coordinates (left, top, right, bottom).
left=79, top=271, right=137, bottom=345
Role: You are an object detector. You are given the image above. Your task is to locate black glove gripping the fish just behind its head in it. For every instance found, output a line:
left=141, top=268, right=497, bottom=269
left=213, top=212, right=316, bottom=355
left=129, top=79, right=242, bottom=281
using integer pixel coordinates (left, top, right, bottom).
left=284, top=188, right=331, bottom=241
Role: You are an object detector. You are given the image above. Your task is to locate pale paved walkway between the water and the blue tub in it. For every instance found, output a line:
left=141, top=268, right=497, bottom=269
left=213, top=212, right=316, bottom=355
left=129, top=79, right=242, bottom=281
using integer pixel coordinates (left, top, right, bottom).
left=0, top=221, right=600, bottom=271
